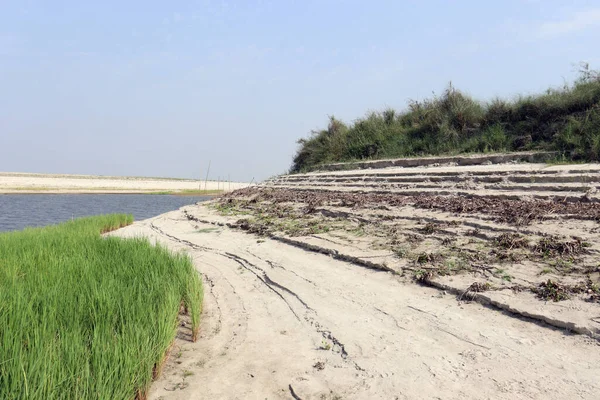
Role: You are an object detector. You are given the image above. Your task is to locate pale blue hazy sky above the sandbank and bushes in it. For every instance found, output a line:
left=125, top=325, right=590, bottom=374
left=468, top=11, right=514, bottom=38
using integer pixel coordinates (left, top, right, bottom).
left=0, top=0, right=600, bottom=180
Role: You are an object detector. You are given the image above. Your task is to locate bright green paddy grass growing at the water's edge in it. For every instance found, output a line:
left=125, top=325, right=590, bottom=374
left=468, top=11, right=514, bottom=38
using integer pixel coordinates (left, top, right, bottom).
left=0, top=215, right=202, bottom=399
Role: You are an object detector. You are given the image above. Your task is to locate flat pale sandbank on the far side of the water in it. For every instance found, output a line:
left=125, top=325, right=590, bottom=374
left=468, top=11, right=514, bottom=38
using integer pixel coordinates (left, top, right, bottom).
left=0, top=172, right=249, bottom=193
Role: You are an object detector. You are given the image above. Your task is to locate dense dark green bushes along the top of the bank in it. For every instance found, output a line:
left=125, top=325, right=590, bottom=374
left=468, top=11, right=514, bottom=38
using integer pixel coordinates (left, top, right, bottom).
left=290, top=65, right=600, bottom=172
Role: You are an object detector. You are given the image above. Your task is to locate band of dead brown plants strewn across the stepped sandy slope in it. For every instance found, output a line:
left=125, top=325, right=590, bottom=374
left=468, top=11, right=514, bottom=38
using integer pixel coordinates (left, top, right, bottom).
left=214, top=187, right=600, bottom=301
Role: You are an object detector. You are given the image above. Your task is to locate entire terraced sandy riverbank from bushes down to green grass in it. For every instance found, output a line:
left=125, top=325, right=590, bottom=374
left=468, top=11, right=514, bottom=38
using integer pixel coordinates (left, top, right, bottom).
left=112, top=157, right=600, bottom=399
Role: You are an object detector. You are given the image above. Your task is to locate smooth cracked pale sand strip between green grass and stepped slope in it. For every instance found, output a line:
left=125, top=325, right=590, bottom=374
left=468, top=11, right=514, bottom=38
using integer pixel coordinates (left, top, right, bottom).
left=116, top=206, right=600, bottom=399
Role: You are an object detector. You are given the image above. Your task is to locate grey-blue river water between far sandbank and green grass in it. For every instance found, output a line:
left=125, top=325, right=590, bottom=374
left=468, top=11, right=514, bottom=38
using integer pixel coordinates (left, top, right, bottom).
left=0, top=194, right=209, bottom=232
